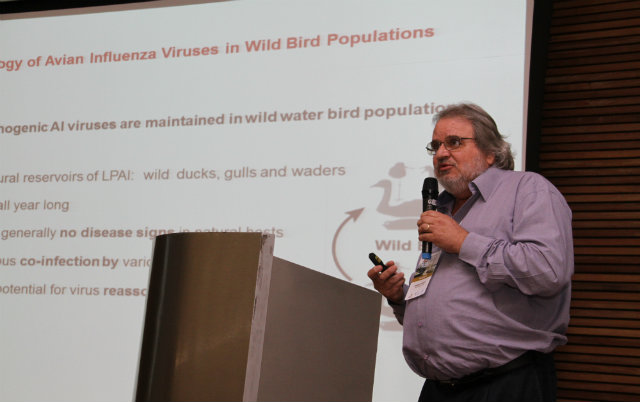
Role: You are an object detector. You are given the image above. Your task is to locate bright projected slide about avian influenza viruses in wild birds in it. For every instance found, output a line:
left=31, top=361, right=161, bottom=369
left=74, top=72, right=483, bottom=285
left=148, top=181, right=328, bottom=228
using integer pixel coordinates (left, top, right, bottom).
left=0, top=0, right=526, bottom=401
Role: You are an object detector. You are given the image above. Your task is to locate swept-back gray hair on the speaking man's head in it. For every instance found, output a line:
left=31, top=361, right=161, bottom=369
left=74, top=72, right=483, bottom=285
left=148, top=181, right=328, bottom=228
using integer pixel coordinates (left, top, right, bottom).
left=433, top=103, right=514, bottom=170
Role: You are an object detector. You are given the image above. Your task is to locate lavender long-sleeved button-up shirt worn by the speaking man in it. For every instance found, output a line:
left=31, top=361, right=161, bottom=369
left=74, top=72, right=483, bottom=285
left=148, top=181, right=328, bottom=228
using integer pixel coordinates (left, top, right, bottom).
left=392, top=168, right=573, bottom=380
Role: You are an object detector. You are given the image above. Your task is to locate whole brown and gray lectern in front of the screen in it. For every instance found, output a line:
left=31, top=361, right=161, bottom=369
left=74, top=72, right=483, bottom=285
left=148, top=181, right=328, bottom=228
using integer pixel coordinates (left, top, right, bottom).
left=136, top=233, right=381, bottom=402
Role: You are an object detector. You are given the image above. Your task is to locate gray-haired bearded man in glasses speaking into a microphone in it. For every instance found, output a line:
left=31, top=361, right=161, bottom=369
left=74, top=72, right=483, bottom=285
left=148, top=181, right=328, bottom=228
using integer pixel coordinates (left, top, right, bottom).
left=368, top=104, right=573, bottom=402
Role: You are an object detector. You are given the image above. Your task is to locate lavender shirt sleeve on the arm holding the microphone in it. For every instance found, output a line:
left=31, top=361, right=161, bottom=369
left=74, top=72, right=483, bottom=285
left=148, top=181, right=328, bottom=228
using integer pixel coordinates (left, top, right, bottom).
left=459, top=175, right=573, bottom=296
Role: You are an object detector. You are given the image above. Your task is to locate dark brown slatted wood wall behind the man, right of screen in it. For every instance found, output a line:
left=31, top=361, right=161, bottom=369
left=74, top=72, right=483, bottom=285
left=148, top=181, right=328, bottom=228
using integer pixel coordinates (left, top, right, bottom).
left=538, top=0, right=640, bottom=402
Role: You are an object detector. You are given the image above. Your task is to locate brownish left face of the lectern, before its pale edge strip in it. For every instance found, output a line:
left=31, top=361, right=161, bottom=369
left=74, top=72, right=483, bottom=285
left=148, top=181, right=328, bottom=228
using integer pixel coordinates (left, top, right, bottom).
left=136, top=233, right=270, bottom=401
